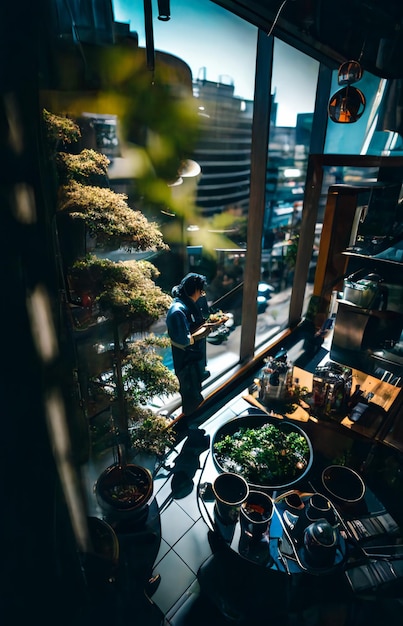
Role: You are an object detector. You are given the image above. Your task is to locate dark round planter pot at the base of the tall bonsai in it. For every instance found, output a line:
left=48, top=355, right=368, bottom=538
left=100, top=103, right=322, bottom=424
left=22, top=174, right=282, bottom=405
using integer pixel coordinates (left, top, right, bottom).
left=95, top=464, right=153, bottom=524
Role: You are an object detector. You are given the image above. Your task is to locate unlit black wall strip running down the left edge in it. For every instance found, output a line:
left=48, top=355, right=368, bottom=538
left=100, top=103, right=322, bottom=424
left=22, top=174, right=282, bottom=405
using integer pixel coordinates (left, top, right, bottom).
left=0, top=0, right=86, bottom=624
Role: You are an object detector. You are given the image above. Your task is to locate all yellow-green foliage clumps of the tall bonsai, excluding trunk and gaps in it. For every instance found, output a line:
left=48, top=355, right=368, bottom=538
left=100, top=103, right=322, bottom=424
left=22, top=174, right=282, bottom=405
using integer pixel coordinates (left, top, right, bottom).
left=43, top=105, right=179, bottom=454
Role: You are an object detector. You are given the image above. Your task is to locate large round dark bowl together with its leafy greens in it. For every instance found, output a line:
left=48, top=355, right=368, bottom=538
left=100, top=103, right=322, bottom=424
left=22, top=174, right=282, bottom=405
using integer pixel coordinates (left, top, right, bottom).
left=211, top=413, right=313, bottom=489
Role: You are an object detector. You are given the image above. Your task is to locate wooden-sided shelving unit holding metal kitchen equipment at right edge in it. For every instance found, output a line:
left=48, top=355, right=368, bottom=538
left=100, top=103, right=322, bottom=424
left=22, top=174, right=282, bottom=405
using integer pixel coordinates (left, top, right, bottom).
left=314, top=182, right=403, bottom=380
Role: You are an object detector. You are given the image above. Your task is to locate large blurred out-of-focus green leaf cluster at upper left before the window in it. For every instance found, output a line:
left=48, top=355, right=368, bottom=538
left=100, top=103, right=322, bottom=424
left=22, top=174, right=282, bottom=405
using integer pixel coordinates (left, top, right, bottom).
left=98, top=47, right=199, bottom=183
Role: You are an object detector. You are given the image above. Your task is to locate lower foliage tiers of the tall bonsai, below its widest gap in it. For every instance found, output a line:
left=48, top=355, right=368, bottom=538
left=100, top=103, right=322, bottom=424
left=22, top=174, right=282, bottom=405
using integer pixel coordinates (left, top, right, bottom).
left=71, top=255, right=178, bottom=454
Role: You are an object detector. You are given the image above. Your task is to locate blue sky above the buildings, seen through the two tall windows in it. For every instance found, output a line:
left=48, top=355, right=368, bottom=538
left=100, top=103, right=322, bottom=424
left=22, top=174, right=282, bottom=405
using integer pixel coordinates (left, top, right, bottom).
left=113, top=0, right=318, bottom=126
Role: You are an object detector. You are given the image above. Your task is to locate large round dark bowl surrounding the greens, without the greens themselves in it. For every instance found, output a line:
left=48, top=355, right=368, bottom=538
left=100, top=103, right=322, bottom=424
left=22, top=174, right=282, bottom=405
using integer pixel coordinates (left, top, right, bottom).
left=211, top=413, right=313, bottom=490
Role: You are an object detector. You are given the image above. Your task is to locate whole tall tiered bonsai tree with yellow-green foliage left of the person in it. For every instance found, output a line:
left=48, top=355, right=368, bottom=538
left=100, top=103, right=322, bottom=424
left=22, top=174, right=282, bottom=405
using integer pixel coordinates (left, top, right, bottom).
left=43, top=110, right=178, bottom=454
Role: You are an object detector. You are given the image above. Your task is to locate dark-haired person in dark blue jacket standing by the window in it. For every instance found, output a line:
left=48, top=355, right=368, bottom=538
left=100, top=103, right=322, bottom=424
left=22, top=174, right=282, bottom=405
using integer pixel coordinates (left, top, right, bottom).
left=166, top=272, right=212, bottom=415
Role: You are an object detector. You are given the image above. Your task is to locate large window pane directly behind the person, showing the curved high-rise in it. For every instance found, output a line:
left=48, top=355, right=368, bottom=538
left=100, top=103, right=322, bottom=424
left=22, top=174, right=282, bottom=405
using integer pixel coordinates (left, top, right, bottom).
left=114, top=0, right=257, bottom=380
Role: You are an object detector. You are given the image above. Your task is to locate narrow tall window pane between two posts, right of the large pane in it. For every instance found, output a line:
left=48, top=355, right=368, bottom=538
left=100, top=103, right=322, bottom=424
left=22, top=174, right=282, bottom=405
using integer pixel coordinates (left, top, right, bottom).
left=256, top=40, right=319, bottom=345
